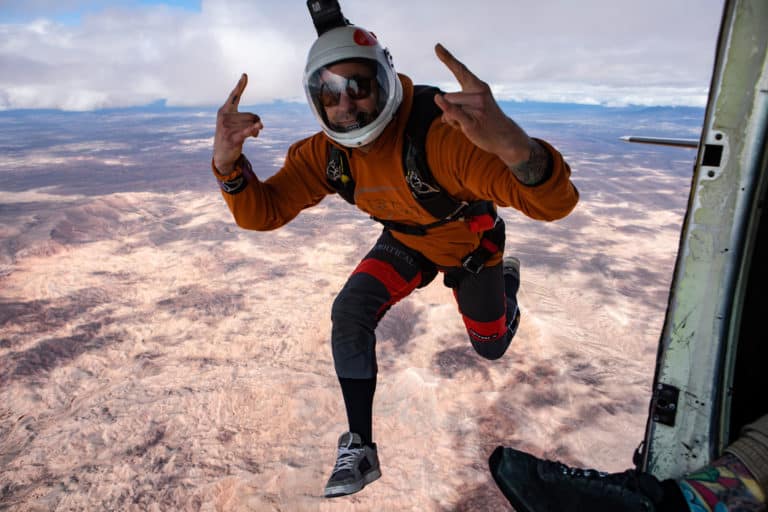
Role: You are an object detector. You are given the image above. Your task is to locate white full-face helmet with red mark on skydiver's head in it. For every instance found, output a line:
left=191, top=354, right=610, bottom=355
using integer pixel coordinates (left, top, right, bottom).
left=304, top=25, right=403, bottom=147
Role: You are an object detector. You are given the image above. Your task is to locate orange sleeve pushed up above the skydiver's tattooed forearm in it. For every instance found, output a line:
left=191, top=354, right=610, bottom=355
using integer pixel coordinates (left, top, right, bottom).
left=426, top=122, right=579, bottom=221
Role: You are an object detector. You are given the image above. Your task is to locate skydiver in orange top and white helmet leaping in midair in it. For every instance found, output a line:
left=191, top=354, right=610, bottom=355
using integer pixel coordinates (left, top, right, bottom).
left=212, top=16, right=578, bottom=497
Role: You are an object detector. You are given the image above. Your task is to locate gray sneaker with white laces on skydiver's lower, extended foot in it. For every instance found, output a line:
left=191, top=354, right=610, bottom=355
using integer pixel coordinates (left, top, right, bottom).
left=325, top=432, right=381, bottom=498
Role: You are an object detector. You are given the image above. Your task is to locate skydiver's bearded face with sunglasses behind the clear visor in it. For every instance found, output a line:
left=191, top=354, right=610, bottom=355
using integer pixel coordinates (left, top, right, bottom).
left=320, top=62, right=379, bottom=131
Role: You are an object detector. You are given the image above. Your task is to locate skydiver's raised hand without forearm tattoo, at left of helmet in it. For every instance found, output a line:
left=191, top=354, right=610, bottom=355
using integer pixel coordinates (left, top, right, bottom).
left=213, top=73, right=264, bottom=175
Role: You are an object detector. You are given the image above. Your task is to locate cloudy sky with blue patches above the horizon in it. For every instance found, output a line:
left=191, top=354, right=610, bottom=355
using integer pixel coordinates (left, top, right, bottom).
left=0, top=0, right=723, bottom=110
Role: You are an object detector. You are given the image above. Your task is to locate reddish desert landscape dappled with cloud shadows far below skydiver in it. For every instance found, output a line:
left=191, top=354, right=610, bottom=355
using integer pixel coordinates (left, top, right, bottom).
left=0, top=104, right=703, bottom=512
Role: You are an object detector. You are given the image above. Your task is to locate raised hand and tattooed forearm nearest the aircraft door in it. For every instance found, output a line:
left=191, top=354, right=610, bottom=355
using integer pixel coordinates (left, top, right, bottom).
left=435, top=43, right=531, bottom=167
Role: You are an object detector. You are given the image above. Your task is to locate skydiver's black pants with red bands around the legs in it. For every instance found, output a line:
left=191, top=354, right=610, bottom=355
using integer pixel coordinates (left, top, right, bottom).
left=331, top=230, right=517, bottom=379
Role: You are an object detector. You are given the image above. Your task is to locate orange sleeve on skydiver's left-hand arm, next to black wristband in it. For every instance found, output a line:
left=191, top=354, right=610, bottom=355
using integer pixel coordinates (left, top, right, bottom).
left=213, top=136, right=334, bottom=231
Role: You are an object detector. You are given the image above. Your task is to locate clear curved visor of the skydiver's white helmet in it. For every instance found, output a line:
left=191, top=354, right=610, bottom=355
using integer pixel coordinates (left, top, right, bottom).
left=307, top=59, right=389, bottom=133
